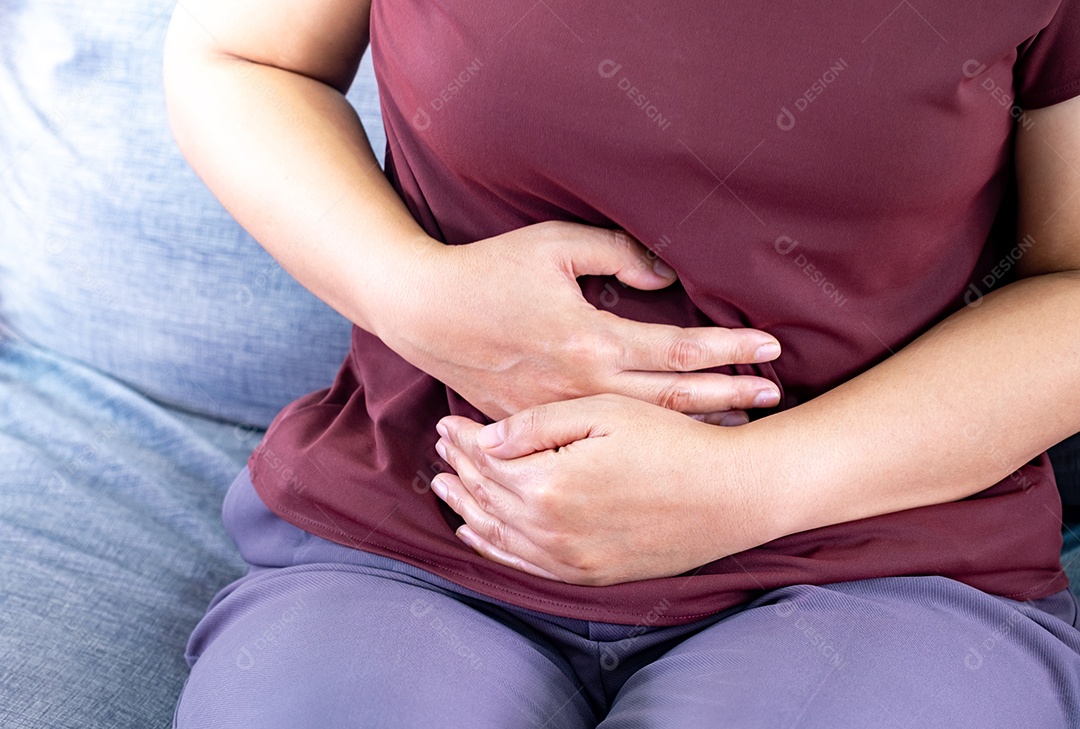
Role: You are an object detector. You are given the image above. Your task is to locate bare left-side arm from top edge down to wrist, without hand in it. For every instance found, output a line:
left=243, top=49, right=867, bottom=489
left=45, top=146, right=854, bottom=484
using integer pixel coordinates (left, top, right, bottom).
left=164, top=0, right=427, bottom=330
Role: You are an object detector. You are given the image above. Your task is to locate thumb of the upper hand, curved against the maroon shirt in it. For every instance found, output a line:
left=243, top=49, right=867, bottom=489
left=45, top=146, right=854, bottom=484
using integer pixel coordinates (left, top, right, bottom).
left=566, top=228, right=677, bottom=291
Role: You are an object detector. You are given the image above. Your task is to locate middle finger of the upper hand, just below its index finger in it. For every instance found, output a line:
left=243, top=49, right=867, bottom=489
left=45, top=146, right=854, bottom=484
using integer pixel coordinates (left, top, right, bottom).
left=612, top=373, right=780, bottom=413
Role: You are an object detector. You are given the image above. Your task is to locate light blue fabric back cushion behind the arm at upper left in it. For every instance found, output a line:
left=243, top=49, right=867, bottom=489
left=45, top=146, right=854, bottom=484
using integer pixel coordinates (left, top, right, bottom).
left=0, top=0, right=386, bottom=426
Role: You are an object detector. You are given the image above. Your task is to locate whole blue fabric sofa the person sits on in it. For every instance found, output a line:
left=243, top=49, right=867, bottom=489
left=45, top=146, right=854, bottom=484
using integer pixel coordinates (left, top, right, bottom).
left=0, top=0, right=1080, bottom=729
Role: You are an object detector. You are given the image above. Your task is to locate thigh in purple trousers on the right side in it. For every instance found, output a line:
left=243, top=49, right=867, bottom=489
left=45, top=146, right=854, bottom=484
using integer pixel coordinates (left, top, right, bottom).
left=599, top=577, right=1080, bottom=729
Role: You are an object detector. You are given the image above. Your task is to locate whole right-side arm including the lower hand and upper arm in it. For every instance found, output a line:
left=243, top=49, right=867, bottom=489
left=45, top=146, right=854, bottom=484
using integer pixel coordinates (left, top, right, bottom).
left=432, top=93, right=1080, bottom=584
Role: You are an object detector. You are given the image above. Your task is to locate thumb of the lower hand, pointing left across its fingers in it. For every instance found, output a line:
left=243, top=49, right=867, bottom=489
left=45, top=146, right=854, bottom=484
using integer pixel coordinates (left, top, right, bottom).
left=476, top=399, right=602, bottom=459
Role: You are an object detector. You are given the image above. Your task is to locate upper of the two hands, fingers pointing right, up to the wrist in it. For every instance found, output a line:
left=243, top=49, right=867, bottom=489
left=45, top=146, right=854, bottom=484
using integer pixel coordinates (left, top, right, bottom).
left=375, top=221, right=780, bottom=424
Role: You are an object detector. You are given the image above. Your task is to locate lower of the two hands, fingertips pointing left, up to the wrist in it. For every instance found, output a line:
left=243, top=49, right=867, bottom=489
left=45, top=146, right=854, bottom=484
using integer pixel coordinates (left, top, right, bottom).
left=433, top=394, right=782, bottom=585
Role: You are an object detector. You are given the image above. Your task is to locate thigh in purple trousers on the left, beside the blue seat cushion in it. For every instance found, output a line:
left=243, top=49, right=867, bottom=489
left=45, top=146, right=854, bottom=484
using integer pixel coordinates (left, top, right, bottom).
left=176, top=564, right=595, bottom=729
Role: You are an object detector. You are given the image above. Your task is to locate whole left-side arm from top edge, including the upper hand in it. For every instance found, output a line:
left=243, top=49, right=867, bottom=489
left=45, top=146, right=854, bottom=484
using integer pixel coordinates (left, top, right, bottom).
left=165, top=0, right=780, bottom=422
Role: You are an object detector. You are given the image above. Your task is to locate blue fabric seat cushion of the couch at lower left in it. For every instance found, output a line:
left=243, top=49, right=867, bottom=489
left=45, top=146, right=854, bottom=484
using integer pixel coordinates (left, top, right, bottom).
left=0, top=338, right=250, bottom=729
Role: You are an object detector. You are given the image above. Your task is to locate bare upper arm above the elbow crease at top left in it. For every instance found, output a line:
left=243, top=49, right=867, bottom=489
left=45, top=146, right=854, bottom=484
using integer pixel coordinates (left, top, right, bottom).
left=165, top=0, right=372, bottom=93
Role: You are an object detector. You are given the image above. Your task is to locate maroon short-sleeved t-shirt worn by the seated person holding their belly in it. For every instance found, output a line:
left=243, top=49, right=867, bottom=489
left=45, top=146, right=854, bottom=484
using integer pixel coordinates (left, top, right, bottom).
left=251, top=0, right=1080, bottom=624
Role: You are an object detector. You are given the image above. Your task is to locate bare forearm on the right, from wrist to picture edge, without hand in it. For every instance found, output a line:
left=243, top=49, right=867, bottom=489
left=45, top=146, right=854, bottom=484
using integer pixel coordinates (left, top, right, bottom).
left=744, top=271, right=1080, bottom=534
